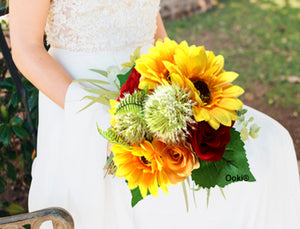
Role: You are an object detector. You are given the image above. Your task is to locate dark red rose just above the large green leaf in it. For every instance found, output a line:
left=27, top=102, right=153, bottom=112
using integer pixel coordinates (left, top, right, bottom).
left=189, top=122, right=231, bottom=161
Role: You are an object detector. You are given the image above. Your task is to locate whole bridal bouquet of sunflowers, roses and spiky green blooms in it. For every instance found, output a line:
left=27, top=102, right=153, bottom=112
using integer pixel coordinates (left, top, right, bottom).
left=78, top=39, right=259, bottom=206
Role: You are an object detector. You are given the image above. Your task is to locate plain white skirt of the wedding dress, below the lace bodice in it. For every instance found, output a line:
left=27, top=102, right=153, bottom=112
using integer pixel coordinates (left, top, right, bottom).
left=29, top=45, right=300, bottom=229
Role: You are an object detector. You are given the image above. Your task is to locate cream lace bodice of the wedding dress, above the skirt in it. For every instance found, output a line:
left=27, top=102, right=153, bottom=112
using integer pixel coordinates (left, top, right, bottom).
left=46, top=0, right=160, bottom=52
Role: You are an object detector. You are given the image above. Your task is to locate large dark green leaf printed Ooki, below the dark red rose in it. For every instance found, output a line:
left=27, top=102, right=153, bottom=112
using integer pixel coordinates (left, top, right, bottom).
left=192, top=128, right=255, bottom=188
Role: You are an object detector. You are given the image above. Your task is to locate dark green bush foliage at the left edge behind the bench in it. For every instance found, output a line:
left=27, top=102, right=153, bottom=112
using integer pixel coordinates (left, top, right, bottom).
left=0, top=67, right=38, bottom=213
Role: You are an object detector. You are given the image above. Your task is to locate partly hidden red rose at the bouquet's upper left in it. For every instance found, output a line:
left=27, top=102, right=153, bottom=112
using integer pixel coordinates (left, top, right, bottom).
left=117, top=68, right=141, bottom=101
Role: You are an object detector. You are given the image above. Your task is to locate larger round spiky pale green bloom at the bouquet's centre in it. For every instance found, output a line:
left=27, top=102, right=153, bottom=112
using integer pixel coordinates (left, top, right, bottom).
left=144, top=85, right=194, bottom=143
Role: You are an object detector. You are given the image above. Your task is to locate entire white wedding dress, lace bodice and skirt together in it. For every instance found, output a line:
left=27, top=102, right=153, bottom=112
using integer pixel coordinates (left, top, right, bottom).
left=29, top=0, right=300, bottom=229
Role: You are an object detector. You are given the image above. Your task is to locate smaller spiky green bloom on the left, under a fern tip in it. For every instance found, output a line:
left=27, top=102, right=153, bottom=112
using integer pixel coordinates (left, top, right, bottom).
left=114, top=90, right=147, bottom=144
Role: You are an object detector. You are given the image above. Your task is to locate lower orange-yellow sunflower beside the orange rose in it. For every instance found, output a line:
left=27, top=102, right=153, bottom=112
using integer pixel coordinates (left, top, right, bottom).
left=110, top=141, right=170, bottom=198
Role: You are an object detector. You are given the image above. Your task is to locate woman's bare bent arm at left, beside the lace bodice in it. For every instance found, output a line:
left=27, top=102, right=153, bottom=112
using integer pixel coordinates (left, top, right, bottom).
left=9, top=0, right=72, bottom=108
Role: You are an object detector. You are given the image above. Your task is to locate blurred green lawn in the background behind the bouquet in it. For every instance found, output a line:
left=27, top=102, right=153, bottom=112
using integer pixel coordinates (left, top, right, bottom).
left=165, top=0, right=300, bottom=113
